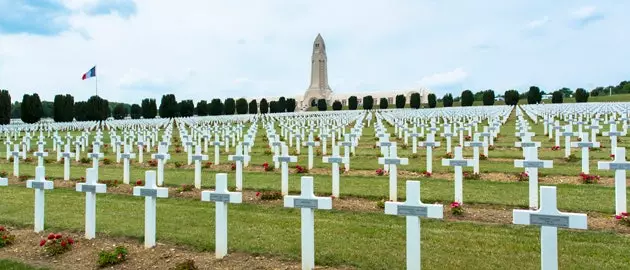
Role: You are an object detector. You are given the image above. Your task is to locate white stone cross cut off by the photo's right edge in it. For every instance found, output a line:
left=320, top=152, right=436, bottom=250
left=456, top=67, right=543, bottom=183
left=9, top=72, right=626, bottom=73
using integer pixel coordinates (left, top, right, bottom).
left=597, top=147, right=630, bottom=215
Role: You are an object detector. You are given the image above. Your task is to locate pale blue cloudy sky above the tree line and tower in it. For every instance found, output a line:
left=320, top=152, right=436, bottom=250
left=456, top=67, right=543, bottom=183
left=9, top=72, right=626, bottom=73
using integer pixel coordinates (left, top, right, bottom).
left=0, top=0, right=630, bottom=103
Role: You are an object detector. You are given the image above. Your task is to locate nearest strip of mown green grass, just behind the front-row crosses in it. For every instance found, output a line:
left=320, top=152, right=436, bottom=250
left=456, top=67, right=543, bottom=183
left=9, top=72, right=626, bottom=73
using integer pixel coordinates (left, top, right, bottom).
left=0, top=186, right=630, bottom=269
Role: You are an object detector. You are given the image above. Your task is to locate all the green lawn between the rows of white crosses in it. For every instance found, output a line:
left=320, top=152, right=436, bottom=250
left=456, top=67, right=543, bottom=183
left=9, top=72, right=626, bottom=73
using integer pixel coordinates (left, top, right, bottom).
left=0, top=106, right=630, bottom=269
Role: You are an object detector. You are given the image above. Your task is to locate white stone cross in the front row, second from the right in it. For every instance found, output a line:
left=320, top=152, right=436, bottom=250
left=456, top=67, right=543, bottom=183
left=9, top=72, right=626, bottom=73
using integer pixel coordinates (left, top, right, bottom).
left=385, top=181, right=444, bottom=270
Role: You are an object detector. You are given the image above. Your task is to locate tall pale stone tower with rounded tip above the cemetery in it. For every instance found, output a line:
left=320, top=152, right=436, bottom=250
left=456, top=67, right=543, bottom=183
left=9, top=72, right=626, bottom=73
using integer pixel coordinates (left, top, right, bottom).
left=302, top=34, right=332, bottom=109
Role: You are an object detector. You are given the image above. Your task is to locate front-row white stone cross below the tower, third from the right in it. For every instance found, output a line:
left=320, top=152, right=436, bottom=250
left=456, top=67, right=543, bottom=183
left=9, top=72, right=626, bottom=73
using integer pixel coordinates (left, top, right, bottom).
left=284, top=176, right=332, bottom=269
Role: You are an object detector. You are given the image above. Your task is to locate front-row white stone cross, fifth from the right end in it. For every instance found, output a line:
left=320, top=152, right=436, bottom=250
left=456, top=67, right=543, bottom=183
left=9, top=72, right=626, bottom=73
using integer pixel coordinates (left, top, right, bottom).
left=133, top=171, right=168, bottom=248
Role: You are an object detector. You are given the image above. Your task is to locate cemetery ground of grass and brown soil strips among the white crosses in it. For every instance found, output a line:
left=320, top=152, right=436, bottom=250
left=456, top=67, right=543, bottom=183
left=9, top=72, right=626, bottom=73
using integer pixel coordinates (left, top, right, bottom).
left=0, top=106, right=630, bottom=269
